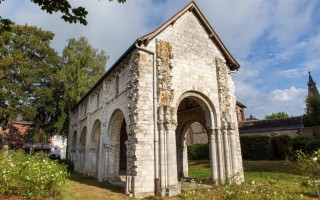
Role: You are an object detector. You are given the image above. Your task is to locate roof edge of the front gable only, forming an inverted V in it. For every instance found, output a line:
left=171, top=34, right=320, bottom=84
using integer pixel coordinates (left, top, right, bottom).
left=138, top=1, right=240, bottom=70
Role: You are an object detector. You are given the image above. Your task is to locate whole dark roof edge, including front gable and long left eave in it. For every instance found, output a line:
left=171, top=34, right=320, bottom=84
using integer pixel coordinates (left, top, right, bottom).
left=71, top=1, right=240, bottom=110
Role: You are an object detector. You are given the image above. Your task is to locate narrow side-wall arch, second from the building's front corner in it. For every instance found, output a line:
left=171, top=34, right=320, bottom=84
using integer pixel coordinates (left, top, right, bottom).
left=89, top=120, right=101, bottom=177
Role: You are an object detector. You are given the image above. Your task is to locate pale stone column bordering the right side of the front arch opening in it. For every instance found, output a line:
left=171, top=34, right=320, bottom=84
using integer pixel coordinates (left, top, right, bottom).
left=207, top=127, right=219, bottom=182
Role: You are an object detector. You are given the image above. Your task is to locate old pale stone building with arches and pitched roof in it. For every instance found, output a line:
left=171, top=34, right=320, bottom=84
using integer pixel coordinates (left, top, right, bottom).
left=68, top=1, right=243, bottom=196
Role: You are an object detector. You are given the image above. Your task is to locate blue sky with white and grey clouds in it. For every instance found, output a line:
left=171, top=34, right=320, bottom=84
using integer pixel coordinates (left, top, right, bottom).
left=0, top=0, right=320, bottom=119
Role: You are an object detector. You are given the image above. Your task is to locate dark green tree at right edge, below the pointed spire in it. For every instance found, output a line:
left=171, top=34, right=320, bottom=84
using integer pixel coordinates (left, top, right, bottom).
left=304, top=95, right=320, bottom=126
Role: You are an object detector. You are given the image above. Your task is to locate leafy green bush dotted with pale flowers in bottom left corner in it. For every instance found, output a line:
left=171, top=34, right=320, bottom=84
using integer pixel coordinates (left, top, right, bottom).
left=0, top=151, right=69, bottom=199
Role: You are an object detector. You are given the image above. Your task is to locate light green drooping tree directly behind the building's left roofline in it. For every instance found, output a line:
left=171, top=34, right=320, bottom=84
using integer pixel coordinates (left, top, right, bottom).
left=57, top=37, right=108, bottom=133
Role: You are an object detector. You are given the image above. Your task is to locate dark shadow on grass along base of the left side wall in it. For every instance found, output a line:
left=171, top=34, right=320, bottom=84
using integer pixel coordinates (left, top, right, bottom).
left=69, top=172, right=124, bottom=194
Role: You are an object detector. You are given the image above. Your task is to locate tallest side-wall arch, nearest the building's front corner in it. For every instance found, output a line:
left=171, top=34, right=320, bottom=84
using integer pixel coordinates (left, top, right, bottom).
left=104, top=110, right=128, bottom=180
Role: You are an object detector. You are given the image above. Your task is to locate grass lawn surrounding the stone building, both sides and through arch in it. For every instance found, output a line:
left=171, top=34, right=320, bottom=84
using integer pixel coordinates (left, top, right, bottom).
left=62, top=161, right=316, bottom=200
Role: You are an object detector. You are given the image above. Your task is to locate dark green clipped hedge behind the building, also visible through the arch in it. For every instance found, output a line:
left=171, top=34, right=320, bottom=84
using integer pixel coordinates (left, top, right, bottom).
left=188, top=135, right=320, bottom=160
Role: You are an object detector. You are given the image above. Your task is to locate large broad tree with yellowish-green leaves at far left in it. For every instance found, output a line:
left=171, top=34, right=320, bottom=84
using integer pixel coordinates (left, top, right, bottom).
left=0, top=25, right=63, bottom=133
